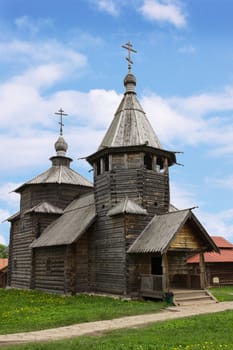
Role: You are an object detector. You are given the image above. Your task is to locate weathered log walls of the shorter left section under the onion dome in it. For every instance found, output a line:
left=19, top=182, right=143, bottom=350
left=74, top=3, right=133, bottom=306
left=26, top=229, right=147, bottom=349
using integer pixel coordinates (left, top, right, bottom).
left=8, top=180, right=92, bottom=291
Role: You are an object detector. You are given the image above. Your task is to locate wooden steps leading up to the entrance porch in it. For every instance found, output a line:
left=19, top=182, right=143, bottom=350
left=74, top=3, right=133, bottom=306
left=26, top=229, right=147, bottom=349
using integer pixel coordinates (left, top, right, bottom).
left=172, top=289, right=218, bottom=306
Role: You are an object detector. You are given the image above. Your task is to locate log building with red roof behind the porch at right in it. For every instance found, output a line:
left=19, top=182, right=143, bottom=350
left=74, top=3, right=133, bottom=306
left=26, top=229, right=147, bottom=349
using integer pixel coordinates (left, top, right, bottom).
left=187, top=236, right=233, bottom=285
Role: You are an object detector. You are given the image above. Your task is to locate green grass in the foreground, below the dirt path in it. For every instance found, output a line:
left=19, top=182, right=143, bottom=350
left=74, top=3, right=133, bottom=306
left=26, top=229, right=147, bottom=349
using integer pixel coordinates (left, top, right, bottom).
left=2, top=311, right=233, bottom=350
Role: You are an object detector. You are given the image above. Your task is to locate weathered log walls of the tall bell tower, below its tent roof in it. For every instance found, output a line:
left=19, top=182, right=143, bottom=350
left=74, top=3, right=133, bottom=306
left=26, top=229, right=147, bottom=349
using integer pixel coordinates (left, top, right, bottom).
left=90, top=152, right=169, bottom=294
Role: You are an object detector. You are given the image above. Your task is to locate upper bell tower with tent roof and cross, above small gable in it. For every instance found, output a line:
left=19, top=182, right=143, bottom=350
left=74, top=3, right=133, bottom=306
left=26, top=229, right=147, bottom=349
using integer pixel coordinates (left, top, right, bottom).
left=87, top=43, right=176, bottom=217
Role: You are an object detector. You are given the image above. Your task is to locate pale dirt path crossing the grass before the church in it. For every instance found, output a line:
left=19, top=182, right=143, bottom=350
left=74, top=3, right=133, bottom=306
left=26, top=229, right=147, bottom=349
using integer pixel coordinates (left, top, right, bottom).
left=0, top=301, right=233, bottom=347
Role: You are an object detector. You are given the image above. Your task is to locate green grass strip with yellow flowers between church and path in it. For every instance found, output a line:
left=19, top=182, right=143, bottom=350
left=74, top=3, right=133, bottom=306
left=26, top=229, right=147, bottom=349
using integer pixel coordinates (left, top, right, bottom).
left=0, top=289, right=166, bottom=334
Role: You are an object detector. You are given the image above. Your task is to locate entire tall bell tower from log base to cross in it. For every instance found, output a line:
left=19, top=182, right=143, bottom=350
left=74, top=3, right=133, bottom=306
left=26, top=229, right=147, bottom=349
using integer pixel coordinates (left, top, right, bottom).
left=87, top=43, right=176, bottom=295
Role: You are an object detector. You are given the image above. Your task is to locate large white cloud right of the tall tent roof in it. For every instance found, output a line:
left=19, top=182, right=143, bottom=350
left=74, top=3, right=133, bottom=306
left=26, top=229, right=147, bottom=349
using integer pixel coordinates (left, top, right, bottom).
left=142, top=87, right=233, bottom=155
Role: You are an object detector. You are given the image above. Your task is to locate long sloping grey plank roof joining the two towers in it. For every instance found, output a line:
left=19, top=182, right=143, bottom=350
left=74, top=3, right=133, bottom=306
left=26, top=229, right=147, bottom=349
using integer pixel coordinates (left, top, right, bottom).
left=31, top=193, right=96, bottom=248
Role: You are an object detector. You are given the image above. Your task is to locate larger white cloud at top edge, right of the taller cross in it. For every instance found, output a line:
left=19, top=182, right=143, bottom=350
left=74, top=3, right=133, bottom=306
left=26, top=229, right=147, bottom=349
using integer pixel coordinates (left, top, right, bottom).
left=140, top=0, right=186, bottom=28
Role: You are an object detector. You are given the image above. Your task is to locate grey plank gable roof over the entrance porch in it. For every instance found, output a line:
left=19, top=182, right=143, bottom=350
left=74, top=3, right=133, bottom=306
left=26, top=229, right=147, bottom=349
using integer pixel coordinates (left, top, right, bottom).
left=128, top=209, right=218, bottom=254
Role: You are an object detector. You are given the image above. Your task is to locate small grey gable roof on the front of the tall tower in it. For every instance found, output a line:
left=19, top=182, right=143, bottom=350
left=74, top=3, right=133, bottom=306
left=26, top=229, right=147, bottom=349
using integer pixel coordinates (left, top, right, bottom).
left=107, top=197, right=148, bottom=216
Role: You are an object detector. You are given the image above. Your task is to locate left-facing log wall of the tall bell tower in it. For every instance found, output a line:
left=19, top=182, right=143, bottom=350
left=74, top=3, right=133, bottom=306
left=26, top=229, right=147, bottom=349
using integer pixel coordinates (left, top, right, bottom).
left=89, top=173, right=126, bottom=294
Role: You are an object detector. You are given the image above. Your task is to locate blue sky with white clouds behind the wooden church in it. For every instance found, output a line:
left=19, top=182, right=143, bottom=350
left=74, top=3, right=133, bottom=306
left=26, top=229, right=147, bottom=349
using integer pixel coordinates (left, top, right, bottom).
left=0, top=0, right=233, bottom=244
